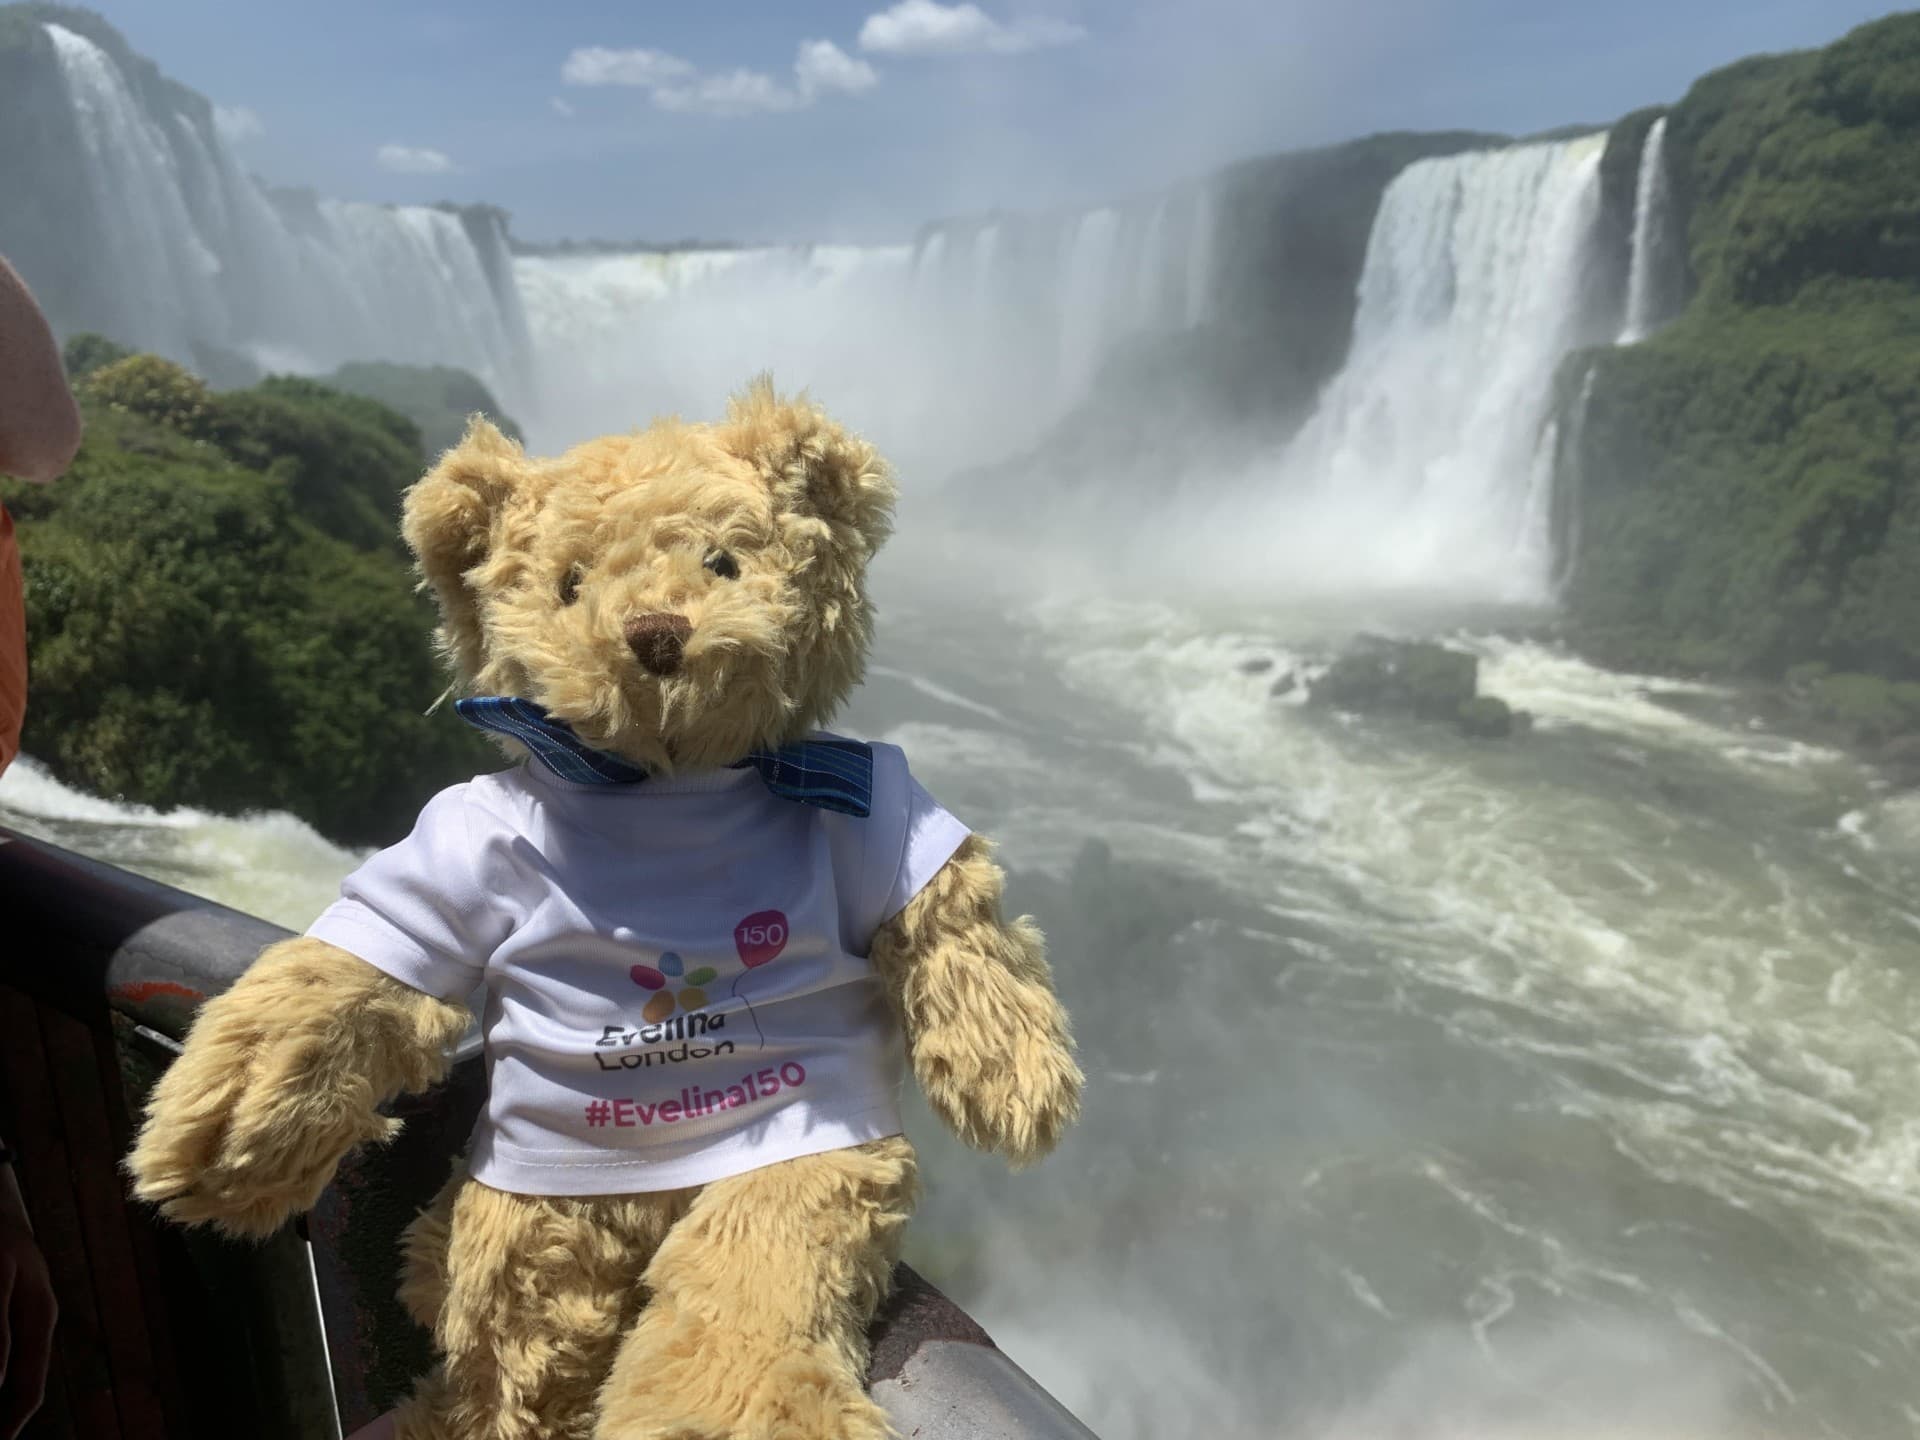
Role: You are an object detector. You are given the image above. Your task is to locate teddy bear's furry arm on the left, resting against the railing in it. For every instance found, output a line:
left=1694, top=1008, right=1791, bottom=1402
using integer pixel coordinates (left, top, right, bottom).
left=127, top=935, right=468, bottom=1236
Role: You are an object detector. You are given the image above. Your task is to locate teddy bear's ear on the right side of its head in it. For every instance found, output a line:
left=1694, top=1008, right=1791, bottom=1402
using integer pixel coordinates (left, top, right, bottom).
left=718, top=374, right=899, bottom=553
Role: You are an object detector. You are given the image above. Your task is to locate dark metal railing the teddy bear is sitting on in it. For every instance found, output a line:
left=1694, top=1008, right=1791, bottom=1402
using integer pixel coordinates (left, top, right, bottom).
left=0, top=828, right=1094, bottom=1440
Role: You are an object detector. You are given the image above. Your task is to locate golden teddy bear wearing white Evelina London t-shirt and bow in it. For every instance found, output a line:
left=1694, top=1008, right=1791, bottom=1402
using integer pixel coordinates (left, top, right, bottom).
left=127, top=376, right=1083, bottom=1440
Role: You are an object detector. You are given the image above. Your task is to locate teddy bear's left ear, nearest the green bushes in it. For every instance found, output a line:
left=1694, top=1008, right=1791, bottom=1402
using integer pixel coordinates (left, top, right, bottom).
left=399, top=415, right=536, bottom=676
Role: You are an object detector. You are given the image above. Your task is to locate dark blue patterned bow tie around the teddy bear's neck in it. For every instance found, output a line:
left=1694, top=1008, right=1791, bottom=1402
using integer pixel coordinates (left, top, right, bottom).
left=453, top=695, right=874, bottom=820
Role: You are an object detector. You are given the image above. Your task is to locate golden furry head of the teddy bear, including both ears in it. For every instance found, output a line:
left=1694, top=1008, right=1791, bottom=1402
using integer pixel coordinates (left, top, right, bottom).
left=401, top=378, right=895, bottom=772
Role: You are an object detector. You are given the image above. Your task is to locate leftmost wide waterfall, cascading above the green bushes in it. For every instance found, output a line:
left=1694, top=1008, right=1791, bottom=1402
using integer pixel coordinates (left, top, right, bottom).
left=26, top=23, right=528, bottom=409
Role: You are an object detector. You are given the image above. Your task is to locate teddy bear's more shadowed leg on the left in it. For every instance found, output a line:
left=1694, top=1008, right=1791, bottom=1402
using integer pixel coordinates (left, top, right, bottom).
left=396, top=1177, right=687, bottom=1440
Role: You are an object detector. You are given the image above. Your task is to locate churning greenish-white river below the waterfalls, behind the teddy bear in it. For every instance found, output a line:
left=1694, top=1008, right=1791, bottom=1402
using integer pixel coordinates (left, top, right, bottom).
left=0, top=564, right=1920, bottom=1440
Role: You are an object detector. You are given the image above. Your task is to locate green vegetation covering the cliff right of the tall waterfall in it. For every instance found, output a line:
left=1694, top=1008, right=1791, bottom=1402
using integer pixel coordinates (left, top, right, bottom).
left=1561, top=15, right=1920, bottom=741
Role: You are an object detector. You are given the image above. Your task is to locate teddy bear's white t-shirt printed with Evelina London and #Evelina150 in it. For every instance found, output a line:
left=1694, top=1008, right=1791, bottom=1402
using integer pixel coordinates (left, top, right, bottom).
left=307, top=745, right=968, bottom=1194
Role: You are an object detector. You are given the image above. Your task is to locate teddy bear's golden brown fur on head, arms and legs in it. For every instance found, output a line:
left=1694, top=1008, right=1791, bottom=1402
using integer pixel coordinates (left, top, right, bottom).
left=129, top=382, right=1081, bottom=1440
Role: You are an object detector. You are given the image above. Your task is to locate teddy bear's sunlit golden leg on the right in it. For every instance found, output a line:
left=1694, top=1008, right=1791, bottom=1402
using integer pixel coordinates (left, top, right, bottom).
left=595, top=1137, right=916, bottom=1440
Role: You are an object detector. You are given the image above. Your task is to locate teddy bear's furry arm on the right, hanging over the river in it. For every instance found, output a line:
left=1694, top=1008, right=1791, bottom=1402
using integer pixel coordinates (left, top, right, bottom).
left=872, top=835, right=1083, bottom=1165
